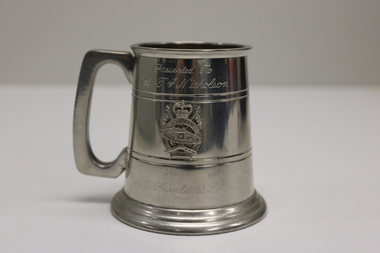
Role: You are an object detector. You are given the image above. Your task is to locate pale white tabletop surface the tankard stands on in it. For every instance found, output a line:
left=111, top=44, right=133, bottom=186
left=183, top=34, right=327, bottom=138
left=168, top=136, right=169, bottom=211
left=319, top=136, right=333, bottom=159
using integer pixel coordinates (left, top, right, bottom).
left=0, top=84, right=380, bottom=252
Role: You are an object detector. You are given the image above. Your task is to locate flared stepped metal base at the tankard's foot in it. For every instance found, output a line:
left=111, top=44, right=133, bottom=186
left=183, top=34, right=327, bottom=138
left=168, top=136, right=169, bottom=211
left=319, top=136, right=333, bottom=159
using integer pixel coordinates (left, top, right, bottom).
left=111, top=190, right=266, bottom=235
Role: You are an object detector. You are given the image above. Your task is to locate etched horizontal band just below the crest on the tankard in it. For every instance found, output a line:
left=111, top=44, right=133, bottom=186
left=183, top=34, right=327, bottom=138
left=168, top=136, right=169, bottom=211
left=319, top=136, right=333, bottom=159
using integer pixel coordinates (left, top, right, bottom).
left=130, top=148, right=252, bottom=168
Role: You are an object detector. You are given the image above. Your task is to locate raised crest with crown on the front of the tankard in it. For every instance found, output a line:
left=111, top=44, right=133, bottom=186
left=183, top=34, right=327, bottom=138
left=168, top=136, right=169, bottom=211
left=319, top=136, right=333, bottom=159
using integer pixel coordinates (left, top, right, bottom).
left=161, top=100, right=203, bottom=158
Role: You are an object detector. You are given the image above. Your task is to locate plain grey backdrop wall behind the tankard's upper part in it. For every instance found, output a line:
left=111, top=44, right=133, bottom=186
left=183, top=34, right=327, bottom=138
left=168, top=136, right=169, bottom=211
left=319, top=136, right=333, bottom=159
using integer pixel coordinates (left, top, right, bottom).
left=0, top=0, right=380, bottom=85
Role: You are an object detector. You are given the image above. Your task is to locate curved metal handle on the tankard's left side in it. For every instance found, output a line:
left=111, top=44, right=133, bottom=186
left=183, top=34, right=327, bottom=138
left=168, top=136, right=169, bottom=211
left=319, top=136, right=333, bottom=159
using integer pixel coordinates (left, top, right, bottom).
left=73, top=50, right=134, bottom=177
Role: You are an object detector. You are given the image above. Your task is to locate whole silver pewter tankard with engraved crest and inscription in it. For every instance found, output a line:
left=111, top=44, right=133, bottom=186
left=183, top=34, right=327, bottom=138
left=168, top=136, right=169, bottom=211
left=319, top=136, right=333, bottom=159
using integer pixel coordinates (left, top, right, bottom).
left=74, top=42, right=266, bottom=235
